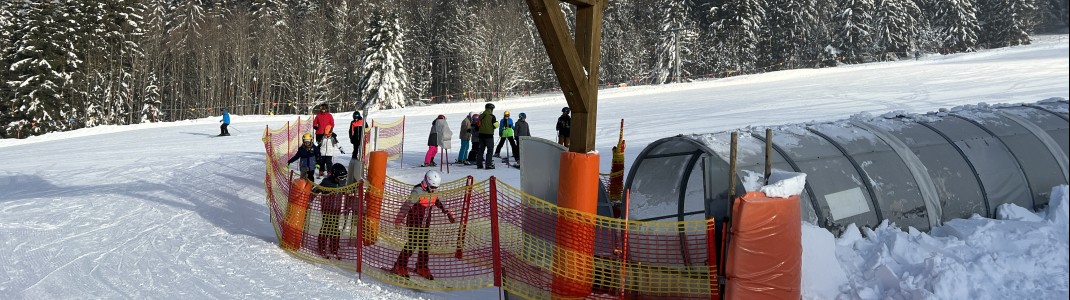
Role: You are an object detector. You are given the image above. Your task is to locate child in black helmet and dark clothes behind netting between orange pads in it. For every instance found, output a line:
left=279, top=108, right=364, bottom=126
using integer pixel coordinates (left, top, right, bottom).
left=312, top=164, right=349, bottom=258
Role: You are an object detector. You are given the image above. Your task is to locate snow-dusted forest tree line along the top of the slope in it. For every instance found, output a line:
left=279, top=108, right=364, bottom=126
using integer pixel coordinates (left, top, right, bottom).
left=0, top=0, right=1067, bottom=138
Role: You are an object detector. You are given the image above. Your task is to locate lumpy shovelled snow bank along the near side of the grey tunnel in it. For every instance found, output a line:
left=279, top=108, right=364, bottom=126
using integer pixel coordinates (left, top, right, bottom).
left=801, top=185, right=1070, bottom=299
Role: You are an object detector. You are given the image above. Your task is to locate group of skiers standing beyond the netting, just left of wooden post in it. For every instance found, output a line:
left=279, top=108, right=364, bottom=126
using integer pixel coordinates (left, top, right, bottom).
left=423, top=103, right=571, bottom=169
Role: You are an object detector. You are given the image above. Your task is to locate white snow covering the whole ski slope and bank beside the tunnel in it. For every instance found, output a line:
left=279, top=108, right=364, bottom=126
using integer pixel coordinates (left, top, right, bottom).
left=0, top=34, right=1070, bottom=299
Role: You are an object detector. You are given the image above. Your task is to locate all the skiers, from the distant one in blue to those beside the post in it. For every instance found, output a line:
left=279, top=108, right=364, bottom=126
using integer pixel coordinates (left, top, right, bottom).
left=280, top=103, right=571, bottom=280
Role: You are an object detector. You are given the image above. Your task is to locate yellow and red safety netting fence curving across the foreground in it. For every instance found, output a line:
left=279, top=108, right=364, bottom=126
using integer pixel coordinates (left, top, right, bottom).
left=263, top=124, right=719, bottom=299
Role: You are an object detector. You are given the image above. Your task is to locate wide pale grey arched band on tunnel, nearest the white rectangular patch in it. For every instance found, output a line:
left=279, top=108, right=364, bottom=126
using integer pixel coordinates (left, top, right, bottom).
left=851, top=121, right=944, bottom=228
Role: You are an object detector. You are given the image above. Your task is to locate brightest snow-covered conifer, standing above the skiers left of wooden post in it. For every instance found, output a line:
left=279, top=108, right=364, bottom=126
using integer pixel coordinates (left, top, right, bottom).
left=357, top=13, right=411, bottom=111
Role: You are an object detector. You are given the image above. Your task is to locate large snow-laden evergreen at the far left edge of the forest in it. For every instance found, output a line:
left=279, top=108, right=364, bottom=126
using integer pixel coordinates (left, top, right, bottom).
left=4, top=0, right=73, bottom=137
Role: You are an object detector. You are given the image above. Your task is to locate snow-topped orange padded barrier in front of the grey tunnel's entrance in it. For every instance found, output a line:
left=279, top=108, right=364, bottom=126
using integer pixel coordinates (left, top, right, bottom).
left=724, top=192, right=803, bottom=300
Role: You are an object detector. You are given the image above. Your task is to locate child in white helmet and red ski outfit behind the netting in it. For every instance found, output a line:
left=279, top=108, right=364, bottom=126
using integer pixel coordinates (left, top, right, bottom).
left=392, top=170, right=455, bottom=280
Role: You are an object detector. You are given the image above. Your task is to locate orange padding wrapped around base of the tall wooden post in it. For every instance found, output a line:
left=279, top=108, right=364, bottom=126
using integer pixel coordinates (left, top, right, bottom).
left=552, top=152, right=598, bottom=299
